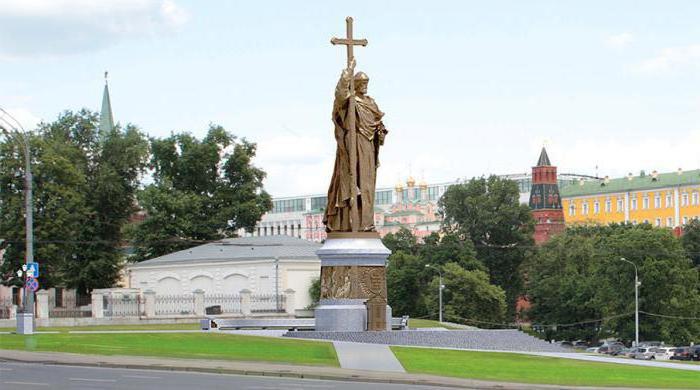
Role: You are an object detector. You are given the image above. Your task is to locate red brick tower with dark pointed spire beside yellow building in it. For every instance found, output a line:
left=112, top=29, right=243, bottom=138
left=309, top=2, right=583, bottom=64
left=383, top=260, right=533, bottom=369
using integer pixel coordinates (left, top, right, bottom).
left=530, top=147, right=564, bottom=245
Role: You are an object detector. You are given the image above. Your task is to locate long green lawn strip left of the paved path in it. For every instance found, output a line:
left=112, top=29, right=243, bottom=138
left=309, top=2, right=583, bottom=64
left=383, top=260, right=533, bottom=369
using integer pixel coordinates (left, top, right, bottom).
left=0, top=333, right=339, bottom=367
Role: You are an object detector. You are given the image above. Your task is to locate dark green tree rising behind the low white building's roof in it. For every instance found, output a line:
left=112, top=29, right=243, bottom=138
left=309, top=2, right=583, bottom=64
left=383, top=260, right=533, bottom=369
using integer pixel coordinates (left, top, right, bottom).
left=130, top=125, right=272, bottom=261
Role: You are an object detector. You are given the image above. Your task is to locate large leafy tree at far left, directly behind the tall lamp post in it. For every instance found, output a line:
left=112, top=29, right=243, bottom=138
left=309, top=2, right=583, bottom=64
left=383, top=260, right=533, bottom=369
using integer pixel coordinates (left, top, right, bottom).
left=0, top=110, right=148, bottom=291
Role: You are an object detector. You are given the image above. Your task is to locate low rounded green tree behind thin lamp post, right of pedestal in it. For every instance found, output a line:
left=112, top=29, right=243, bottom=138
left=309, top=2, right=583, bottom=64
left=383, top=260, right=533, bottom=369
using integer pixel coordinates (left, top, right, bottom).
left=425, top=263, right=506, bottom=327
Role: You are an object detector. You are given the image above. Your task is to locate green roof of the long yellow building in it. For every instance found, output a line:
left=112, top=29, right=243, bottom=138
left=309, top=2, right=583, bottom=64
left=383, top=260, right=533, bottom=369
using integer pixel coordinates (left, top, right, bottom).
left=560, top=169, right=700, bottom=198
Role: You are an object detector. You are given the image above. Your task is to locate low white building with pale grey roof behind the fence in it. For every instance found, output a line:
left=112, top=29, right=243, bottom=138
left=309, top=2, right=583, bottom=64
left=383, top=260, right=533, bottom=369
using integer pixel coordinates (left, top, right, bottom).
left=127, top=235, right=321, bottom=310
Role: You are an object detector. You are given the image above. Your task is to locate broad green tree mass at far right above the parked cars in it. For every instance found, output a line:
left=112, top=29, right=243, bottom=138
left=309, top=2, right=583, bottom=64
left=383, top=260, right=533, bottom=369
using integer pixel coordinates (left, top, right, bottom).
left=528, top=224, right=700, bottom=343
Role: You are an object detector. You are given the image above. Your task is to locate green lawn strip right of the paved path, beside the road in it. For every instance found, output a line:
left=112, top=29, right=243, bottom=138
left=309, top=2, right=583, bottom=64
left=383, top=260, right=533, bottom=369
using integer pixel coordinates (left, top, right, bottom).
left=391, top=347, right=700, bottom=389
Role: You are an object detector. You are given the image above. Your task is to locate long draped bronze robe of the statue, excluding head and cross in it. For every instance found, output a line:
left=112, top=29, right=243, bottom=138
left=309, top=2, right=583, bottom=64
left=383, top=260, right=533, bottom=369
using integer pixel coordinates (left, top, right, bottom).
left=323, top=70, right=387, bottom=232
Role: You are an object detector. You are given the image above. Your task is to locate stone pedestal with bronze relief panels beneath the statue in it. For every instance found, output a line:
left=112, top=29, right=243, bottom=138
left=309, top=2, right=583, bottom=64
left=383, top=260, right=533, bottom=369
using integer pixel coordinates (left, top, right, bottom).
left=315, top=232, right=391, bottom=332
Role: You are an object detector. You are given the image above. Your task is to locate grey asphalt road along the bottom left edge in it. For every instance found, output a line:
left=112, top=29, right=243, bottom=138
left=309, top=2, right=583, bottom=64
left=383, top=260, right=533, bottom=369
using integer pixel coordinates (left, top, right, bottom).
left=0, top=362, right=444, bottom=390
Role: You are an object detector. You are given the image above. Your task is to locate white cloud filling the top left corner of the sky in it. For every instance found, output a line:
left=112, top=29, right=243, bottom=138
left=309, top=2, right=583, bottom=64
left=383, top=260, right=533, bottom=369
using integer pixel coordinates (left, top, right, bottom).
left=0, top=0, right=189, bottom=58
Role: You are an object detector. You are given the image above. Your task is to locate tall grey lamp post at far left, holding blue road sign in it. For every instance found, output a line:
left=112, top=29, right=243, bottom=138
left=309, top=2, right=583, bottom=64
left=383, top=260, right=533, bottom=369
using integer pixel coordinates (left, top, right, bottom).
left=0, top=108, right=34, bottom=333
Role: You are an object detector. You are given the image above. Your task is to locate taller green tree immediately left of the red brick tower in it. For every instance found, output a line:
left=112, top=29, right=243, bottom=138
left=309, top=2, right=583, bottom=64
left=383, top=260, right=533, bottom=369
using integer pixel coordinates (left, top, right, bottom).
left=438, top=176, right=534, bottom=317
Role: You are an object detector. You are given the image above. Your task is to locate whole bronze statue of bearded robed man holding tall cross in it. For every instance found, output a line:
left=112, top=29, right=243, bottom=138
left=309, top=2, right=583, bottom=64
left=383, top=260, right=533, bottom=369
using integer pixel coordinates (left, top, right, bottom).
left=323, top=17, right=387, bottom=232
